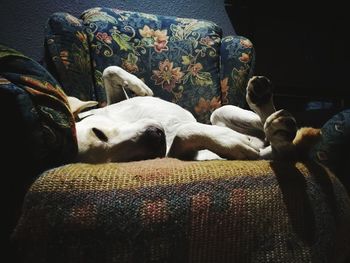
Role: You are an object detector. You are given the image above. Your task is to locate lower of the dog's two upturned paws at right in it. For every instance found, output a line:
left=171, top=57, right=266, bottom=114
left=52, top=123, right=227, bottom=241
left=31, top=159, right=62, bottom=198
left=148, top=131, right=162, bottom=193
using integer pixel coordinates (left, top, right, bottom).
left=264, top=110, right=297, bottom=153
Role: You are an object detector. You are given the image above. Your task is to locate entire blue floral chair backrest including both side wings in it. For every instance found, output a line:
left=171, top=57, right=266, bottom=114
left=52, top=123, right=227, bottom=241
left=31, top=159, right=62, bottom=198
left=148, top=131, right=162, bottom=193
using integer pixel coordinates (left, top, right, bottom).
left=46, top=8, right=254, bottom=123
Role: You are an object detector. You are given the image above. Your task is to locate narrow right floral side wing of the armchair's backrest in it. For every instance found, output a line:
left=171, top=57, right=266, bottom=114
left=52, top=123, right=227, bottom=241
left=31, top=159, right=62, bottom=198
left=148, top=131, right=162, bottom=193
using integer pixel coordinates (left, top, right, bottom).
left=220, top=36, right=255, bottom=108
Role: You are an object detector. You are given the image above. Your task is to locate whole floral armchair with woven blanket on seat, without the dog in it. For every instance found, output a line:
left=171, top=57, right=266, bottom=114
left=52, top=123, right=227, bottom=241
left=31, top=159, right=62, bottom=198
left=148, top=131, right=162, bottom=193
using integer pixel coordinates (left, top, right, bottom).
left=0, top=8, right=350, bottom=262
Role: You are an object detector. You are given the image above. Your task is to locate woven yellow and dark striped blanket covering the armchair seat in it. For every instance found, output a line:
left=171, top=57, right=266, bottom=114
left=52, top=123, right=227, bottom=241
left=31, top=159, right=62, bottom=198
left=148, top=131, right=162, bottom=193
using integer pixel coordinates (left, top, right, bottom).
left=14, top=158, right=350, bottom=262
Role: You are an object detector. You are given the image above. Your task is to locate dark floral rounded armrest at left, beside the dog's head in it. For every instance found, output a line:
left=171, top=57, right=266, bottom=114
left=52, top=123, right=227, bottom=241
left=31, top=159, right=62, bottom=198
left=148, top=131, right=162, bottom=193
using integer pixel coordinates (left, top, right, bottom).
left=0, top=45, right=77, bottom=174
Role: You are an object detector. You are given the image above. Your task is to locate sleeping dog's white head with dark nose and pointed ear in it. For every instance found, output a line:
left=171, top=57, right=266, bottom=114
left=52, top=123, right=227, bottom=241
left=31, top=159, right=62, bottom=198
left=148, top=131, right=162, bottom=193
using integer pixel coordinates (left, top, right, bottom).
left=69, top=98, right=166, bottom=163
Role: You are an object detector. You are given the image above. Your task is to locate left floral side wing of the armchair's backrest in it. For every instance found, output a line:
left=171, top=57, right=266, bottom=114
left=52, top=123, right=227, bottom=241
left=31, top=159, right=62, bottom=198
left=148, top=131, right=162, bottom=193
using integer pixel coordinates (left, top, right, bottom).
left=44, top=13, right=95, bottom=100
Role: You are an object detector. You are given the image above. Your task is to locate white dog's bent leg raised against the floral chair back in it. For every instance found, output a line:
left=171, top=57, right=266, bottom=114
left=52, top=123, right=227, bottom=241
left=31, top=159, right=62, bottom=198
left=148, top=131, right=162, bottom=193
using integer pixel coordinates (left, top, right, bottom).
left=102, top=66, right=153, bottom=105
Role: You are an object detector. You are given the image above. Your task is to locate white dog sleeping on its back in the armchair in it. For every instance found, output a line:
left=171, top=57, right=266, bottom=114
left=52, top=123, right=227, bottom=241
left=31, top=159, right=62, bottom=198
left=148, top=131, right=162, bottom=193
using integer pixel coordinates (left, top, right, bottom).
left=68, top=66, right=319, bottom=163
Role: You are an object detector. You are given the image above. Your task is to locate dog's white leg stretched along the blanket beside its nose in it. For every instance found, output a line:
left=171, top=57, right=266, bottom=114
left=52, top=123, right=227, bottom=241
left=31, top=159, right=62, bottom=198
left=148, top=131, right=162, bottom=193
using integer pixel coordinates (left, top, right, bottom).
left=168, top=122, right=259, bottom=160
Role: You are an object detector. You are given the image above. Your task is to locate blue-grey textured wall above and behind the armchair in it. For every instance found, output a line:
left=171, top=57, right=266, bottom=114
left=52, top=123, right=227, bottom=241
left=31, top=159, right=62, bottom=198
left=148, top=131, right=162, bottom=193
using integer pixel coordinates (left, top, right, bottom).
left=0, top=0, right=234, bottom=60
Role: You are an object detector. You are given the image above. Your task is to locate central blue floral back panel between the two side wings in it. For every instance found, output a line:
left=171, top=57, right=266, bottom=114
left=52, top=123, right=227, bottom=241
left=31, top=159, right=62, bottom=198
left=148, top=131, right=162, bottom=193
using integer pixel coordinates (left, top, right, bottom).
left=82, top=8, right=222, bottom=122
